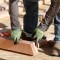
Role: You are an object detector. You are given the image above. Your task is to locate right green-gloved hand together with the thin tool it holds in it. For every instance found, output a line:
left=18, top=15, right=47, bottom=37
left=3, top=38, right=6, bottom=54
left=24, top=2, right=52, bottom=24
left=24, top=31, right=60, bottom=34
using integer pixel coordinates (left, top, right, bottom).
left=33, top=28, right=44, bottom=47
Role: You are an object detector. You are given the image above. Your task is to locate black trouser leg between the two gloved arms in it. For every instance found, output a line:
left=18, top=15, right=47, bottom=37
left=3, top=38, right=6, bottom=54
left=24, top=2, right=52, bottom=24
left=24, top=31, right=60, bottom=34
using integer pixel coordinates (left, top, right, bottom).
left=23, top=0, right=38, bottom=33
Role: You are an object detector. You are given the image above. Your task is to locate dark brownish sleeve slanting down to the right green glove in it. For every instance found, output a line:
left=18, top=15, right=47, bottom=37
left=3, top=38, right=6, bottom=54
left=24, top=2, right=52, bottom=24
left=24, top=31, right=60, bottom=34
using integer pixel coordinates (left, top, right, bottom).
left=38, top=0, right=60, bottom=31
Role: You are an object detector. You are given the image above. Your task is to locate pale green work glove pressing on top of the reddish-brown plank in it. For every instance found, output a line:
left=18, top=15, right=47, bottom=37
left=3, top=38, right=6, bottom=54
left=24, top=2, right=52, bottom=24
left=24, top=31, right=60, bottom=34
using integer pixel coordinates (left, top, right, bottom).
left=11, top=29, right=21, bottom=44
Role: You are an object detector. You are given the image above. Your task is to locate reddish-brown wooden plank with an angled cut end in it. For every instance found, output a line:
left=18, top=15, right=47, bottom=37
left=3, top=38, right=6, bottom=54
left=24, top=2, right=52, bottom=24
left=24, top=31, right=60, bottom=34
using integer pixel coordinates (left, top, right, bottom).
left=0, top=37, right=38, bottom=55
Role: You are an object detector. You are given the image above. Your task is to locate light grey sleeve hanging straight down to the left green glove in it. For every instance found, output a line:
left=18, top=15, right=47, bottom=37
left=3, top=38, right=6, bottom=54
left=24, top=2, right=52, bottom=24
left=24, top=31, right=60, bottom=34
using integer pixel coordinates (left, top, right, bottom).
left=9, top=0, right=20, bottom=30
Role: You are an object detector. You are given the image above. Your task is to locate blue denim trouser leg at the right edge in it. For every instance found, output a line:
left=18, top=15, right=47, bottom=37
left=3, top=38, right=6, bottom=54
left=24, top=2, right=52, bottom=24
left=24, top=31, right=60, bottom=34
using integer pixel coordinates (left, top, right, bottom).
left=54, top=11, right=60, bottom=41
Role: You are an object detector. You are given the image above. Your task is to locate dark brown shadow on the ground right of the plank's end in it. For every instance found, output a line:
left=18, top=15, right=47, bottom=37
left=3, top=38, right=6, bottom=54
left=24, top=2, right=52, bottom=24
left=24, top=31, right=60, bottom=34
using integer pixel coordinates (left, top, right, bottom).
left=39, top=40, right=60, bottom=57
